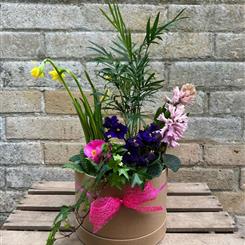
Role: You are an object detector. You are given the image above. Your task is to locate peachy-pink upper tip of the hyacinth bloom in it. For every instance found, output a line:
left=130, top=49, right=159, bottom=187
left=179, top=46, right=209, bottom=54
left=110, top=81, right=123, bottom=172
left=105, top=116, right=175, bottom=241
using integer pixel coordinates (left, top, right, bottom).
left=167, top=83, right=196, bottom=105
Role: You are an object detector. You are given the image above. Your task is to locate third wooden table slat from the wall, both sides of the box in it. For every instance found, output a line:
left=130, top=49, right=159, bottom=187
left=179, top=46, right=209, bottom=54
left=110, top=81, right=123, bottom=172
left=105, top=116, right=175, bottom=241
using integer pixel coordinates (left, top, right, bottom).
left=3, top=210, right=236, bottom=232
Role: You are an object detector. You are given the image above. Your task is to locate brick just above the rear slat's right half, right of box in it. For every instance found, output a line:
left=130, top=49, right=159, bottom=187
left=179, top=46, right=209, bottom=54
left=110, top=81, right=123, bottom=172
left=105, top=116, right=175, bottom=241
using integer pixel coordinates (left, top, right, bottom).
left=169, top=167, right=237, bottom=190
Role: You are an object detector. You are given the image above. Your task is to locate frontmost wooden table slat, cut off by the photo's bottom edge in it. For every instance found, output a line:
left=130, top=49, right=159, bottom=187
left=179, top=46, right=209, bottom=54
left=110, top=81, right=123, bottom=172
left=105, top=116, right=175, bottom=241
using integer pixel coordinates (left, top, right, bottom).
left=0, top=231, right=245, bottom=245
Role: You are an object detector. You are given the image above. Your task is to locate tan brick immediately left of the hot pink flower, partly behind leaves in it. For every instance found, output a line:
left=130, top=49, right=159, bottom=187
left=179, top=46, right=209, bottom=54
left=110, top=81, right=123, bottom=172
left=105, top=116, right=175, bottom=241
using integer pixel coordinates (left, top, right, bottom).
left=44, top=142, right=82, bottom=164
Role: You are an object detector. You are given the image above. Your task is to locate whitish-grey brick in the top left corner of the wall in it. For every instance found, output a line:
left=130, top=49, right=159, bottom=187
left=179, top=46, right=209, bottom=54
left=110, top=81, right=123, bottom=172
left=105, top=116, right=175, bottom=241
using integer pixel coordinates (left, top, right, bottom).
left=1, top=3, right=84, bottom=29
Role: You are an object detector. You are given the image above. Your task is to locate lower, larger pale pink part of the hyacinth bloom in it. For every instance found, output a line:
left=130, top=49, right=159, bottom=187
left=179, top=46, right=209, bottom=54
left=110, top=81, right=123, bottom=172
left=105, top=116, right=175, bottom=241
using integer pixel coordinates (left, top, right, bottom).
left=157, top=104, right=188, bottom=147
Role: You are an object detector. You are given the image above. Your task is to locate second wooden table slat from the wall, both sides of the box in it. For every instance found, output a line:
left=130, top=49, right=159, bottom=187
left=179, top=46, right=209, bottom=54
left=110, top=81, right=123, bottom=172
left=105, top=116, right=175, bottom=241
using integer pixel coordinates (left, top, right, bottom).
left=17, top=195, right=222, bottom=212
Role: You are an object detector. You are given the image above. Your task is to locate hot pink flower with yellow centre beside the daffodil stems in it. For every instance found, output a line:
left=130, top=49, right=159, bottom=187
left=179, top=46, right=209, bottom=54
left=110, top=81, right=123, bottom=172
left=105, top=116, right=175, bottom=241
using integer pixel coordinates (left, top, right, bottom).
left=84, top=140, right=105, bottom=163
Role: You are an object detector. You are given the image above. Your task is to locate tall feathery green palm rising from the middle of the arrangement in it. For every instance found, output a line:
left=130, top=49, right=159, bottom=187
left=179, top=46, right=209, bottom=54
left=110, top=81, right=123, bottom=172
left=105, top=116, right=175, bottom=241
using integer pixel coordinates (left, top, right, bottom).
left=90, top=4, right=186, bottom=137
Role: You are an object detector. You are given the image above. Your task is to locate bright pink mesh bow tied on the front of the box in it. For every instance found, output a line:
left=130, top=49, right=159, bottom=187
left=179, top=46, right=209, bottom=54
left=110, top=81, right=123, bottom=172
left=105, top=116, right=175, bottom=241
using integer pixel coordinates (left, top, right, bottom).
left=89, top=182, right=166, bottom=233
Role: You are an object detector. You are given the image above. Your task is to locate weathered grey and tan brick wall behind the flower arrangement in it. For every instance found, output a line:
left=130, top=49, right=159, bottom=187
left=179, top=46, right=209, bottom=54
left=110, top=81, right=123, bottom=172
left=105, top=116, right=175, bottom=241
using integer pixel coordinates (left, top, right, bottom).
left=0, top=0, right=245, bottom=223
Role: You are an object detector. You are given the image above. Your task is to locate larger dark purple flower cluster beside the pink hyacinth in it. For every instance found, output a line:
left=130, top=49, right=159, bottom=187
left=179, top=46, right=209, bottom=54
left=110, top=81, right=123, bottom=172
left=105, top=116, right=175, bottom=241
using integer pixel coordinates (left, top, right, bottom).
left=123, top=123, right=161, bottom=166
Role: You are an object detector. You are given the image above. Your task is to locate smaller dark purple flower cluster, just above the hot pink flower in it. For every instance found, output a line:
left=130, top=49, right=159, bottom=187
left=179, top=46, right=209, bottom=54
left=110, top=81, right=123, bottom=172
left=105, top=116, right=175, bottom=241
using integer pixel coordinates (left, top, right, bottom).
left=103, top=116, right=128, bottom=139
